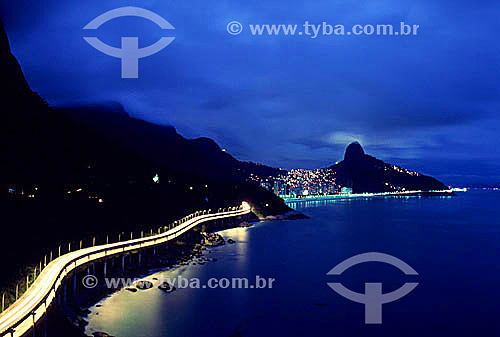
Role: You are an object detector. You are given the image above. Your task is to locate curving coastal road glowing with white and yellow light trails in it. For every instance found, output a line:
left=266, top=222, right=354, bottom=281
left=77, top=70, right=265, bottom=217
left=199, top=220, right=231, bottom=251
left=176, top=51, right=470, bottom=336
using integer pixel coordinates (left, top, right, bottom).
left=0, top=202, right=251, bottom=337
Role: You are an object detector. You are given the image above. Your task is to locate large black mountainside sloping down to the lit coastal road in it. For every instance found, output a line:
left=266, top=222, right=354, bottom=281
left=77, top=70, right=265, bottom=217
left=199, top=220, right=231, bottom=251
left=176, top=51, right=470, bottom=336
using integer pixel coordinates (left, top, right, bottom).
left=0, top=22, right=290, bottom=288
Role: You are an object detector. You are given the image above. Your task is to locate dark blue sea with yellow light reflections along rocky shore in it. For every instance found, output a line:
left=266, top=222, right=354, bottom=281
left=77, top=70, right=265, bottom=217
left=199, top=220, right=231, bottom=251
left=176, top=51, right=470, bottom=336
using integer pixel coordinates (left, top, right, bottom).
left=87, top=190, right=500, bottom=337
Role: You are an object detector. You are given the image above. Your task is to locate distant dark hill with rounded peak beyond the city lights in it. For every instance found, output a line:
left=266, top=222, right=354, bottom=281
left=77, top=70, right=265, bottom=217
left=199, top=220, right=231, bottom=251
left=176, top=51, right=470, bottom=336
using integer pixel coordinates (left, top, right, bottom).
left=330, top=142, right=448, bottom=193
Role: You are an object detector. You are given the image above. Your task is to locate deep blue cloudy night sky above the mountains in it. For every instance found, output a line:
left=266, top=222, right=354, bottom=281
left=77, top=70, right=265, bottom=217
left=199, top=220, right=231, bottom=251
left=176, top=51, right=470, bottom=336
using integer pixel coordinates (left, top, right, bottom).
left=0, top=0, right=500, bottom=185
